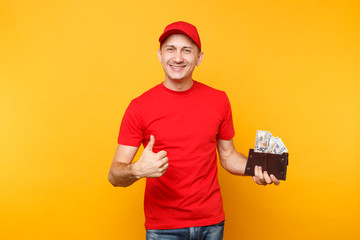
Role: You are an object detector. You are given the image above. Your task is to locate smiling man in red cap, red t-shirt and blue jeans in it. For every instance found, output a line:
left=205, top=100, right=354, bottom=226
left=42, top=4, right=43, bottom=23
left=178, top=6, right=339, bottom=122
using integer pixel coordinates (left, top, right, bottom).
left=109, top=22, right=279, bottom=239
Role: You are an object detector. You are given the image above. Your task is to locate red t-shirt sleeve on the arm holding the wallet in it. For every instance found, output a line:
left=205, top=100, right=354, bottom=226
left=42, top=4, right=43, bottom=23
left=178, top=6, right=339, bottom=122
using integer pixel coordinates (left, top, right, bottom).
left=218, top=93, right=235, bottom=140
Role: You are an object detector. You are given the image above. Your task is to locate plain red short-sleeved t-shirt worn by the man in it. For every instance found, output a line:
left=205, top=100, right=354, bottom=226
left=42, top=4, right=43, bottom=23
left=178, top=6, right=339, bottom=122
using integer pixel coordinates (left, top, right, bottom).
left=118, top=81, right=235, bottom=229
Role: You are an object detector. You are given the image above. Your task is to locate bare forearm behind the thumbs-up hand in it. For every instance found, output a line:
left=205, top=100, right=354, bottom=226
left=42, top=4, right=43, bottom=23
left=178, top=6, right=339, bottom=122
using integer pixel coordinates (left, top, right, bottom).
left=108, top=162, right=140, bottom=187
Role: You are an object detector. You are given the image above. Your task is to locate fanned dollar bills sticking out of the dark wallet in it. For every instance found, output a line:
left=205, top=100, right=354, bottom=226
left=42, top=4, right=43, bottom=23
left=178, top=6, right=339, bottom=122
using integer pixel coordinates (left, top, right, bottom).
left=254, top=130, right=287, bottom=155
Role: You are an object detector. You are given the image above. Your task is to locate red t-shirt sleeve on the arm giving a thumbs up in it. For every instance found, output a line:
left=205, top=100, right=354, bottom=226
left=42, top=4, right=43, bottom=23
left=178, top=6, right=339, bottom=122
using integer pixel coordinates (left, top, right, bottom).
left=118, top=100, right=144, bottom=147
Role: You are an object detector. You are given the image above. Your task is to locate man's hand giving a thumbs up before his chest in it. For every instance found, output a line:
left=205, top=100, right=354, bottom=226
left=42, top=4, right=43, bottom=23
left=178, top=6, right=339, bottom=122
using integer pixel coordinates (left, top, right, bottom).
left=132, top=135, right=169, bottom=178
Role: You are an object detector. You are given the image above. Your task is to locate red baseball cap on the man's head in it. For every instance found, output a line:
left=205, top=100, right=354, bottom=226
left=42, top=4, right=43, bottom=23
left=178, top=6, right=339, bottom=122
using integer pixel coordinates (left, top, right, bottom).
left=159, top=21, right=201, bottom=51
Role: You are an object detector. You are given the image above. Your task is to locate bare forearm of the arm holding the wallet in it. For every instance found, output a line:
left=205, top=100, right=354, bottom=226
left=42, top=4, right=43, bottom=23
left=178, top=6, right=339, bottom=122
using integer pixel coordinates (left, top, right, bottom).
left=220, top=149, right=247, bottom=175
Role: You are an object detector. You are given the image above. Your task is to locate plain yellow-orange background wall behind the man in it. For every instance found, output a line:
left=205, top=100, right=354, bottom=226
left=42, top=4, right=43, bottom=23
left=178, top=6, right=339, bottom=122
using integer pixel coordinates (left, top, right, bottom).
left=0, top=0, right=360, bottom=240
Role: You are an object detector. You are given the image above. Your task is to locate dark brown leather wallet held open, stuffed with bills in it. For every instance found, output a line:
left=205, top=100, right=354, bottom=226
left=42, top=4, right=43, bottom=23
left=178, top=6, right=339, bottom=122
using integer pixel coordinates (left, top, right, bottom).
left=245, top=149, right=289, bottom=180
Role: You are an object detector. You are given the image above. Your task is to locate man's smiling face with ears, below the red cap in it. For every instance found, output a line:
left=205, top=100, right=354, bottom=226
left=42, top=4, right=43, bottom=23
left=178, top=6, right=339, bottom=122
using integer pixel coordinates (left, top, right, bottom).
left=158, top=34, right=204, bottom=82
